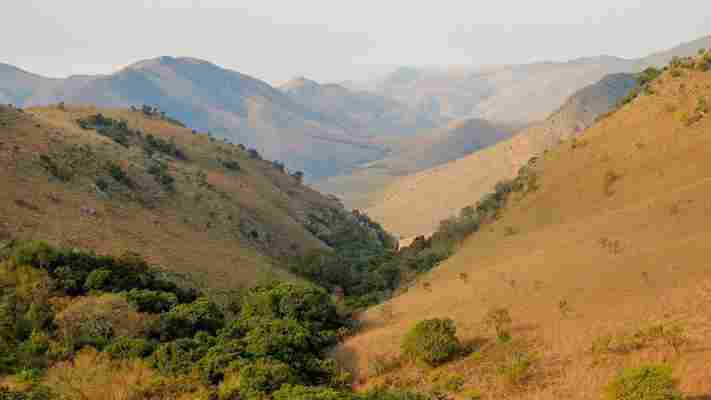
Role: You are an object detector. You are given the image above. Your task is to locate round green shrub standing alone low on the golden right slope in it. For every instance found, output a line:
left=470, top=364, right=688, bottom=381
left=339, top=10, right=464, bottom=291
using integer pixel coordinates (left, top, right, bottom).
left=402, top=319, right=461, bottom=366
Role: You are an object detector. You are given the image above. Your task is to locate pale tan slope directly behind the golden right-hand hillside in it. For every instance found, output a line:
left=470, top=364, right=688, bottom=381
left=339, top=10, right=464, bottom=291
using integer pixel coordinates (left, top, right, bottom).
left=367, top=74, right=635, bottom=238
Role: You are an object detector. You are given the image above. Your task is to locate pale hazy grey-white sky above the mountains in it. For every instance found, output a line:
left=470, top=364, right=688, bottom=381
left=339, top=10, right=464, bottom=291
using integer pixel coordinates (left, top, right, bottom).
left=5, top=0, right=711, bottom=83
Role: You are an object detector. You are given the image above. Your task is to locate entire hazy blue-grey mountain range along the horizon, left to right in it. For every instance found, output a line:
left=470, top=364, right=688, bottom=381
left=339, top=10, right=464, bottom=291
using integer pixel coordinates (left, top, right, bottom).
left=0, top=36, right=711, bottom=181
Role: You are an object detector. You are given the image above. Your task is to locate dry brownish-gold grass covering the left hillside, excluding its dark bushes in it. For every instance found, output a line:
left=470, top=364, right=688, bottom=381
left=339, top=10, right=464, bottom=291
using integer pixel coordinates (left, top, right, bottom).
left=0, top=107, right=336, bottom=287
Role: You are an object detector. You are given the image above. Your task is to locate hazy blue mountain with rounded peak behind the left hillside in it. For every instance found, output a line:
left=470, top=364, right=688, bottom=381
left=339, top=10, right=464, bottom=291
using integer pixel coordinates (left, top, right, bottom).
left=0, top=57, right=398, bottom=177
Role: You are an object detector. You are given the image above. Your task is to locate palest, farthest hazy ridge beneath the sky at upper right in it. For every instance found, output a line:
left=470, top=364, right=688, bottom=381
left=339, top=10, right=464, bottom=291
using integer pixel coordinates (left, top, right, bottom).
left=358, top=36, right=711, bottom=124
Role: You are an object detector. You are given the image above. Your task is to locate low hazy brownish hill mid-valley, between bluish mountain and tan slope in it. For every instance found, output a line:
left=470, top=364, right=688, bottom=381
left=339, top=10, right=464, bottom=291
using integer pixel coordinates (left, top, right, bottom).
left=313, top=118, right=516, bottom=208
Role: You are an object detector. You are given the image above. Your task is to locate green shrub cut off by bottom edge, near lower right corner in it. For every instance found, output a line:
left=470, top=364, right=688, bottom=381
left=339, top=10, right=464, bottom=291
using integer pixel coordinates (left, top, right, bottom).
left=606, top=365, right=682, bottom=400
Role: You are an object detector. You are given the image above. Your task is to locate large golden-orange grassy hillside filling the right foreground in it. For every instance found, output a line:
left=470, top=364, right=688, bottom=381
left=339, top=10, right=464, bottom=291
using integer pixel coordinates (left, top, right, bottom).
left=338, top=55, right=711, bottom=399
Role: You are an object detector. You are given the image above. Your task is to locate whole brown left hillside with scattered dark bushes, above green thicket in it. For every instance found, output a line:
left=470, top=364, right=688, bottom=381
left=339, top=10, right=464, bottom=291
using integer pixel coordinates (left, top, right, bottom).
left=0, top=106, right=394, bottom=288
